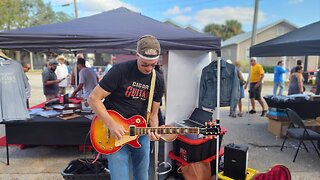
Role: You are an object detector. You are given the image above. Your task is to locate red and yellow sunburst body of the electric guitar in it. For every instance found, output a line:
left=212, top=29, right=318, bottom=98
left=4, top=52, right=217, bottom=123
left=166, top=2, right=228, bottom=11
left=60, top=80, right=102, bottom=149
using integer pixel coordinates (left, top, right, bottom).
left=90, top=110, right=147, bottom=154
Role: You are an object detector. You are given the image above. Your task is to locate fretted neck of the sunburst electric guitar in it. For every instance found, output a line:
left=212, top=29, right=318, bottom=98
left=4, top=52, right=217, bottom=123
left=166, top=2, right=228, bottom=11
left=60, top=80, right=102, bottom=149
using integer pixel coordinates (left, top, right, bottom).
left=130, top=126, right=200, bottom=136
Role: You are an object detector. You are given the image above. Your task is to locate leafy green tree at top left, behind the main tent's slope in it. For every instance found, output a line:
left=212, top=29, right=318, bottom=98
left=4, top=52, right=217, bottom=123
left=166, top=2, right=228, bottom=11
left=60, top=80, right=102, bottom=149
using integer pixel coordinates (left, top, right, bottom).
left=0, top=0, right=72, bottom=30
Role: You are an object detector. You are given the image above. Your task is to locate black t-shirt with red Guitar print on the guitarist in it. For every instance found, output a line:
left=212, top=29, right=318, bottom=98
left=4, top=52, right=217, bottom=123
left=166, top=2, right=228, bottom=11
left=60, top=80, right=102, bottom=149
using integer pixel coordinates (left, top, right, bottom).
left=99, top=60, right=164, bottom=118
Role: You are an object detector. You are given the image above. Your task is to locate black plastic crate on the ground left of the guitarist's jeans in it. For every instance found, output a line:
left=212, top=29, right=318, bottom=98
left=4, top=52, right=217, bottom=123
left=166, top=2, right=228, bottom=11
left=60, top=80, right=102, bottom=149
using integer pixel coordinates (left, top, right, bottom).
left=61, top=159, right=110, bottom=180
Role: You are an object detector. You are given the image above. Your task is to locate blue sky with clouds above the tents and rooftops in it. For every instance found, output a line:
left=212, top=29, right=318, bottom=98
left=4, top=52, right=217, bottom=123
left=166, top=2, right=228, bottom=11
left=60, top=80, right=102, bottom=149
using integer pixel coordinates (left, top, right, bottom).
left=48, top=0, right=320, bottom=32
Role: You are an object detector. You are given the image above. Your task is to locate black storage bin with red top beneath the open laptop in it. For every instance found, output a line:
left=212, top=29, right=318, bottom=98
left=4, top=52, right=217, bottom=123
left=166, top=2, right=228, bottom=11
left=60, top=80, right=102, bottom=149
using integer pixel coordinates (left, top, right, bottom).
left=173, top=127, right=227, bottom=163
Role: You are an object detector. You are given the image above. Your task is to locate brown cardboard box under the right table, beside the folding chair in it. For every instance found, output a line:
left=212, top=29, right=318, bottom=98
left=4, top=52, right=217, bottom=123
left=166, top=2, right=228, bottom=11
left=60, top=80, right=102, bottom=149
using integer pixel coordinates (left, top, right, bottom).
left=268, top=119, right=289, bottom=137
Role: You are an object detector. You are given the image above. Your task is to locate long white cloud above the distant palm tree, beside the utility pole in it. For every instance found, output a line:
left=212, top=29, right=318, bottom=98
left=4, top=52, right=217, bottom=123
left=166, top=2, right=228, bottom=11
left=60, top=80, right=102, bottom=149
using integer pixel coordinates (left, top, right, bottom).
left=194, top=7, right=266, bottom=26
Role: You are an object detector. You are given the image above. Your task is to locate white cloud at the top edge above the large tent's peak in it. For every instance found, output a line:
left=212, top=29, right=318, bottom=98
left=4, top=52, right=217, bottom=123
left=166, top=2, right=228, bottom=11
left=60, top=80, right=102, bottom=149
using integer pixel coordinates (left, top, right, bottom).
left=78, top=0, right=138, bottom=16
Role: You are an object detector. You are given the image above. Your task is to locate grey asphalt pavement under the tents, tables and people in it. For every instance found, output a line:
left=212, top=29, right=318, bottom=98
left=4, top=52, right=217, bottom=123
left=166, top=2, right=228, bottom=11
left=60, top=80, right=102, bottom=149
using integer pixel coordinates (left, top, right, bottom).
left=0, top=73, right=320, bottom=180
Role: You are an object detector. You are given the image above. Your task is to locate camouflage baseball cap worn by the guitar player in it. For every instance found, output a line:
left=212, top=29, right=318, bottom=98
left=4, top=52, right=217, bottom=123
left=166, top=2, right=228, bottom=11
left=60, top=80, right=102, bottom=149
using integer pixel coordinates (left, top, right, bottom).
left=137, top=35, right=161, bottom=60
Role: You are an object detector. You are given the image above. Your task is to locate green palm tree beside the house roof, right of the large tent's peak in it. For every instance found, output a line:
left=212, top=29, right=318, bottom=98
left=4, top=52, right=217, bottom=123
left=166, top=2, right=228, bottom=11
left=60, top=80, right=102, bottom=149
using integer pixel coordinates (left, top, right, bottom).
left=203, top=20, right=243, bottom=41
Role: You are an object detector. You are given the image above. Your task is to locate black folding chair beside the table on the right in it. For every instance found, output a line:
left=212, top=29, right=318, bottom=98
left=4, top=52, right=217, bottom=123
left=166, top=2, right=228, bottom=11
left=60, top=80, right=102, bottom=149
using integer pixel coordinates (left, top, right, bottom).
left=281, top=108, right=320, bottom=162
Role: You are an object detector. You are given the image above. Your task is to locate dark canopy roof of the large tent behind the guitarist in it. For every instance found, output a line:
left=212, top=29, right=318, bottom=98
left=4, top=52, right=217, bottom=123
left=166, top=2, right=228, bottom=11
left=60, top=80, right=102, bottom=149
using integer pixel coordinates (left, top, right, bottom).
left=0, top=8, right=220, bottom=52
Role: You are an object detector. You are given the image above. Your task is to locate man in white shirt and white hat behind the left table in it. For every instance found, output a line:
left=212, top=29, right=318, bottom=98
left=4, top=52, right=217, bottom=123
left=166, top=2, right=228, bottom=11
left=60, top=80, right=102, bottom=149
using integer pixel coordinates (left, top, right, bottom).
left=55, top=55, right=69, bottom=94
